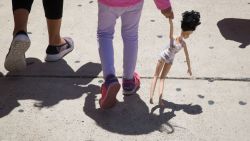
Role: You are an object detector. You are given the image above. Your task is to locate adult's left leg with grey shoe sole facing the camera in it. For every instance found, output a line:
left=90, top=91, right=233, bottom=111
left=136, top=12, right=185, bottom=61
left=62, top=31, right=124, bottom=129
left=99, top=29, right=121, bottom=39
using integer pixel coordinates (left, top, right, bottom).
left=4, top=0, right=33, bottom=72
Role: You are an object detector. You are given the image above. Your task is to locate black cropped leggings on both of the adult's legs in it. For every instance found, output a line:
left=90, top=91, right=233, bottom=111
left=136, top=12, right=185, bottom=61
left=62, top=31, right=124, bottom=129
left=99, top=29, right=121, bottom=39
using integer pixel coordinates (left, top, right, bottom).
left=12, top=0, right=63, bottom=20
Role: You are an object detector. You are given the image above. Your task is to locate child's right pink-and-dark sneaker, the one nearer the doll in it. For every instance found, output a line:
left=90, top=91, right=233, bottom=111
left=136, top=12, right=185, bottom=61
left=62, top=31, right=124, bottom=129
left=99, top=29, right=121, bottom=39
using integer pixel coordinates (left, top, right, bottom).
left=122, top=72, right=141, bottom=95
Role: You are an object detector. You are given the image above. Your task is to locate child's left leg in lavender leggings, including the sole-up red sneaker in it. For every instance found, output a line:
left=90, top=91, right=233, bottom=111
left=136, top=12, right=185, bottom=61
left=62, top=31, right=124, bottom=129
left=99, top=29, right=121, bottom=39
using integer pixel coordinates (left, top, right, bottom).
left=97, top=3, right=122, bottom=109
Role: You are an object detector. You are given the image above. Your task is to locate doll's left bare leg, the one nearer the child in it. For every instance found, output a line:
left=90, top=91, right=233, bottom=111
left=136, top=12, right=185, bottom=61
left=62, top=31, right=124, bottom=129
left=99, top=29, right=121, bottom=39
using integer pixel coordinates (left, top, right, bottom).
left=149, top=60, right=165, bottom=104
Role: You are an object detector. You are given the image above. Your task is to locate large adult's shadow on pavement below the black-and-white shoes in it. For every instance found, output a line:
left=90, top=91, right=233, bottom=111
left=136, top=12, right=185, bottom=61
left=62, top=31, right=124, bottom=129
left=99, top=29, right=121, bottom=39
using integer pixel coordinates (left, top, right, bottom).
left=0, top=58, right=101, bottom=118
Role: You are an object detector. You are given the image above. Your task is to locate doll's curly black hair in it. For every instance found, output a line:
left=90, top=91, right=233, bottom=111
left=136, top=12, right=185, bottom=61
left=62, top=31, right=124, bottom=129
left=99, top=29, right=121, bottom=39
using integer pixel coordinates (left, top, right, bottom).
left=181, top=10, right=201, bottom=31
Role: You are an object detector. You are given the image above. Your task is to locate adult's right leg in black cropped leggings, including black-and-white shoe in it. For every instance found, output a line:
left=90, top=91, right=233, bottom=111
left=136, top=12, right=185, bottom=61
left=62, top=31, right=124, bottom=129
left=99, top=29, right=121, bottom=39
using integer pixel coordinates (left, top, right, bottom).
left=43, top=0, right=74, bottom=61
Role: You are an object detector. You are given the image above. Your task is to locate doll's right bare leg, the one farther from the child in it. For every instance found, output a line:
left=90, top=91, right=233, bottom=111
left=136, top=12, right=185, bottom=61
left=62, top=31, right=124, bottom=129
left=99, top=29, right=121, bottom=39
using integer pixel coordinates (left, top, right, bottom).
left=159, top=63, right=171, bottom=105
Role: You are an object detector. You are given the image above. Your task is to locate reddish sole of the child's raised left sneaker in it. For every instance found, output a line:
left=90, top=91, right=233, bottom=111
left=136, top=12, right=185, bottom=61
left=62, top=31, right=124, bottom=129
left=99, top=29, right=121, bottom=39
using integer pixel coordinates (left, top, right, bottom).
left=100, top=83, right=121, bottom=109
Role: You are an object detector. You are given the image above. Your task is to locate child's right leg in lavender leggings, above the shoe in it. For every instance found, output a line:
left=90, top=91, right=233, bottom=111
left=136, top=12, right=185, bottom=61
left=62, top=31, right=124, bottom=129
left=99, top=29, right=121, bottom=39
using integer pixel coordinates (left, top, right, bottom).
left=121, top=2, right=143, bottom=79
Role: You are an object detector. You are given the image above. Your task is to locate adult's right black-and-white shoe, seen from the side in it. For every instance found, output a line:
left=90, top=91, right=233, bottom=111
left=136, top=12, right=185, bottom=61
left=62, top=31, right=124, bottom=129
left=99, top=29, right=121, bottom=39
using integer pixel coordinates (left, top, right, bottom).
left=45, top=37, right=74, bottom=62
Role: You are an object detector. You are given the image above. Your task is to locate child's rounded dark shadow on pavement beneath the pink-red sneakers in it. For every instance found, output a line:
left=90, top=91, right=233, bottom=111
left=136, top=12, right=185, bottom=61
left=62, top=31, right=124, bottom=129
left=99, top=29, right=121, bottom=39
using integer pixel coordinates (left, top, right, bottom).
left=83, top=94, right=178, bottom=135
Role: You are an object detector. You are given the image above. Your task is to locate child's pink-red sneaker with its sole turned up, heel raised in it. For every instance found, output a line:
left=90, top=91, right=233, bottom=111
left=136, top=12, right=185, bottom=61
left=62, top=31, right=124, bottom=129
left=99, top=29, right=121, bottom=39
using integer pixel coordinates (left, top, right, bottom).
left=99, top=75, right=121, bottom=109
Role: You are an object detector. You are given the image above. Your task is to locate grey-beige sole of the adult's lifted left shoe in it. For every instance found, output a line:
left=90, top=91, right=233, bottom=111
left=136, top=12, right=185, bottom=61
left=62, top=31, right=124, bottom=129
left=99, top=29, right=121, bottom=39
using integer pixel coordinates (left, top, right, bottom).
left=4, top=40, right=30, bottom=72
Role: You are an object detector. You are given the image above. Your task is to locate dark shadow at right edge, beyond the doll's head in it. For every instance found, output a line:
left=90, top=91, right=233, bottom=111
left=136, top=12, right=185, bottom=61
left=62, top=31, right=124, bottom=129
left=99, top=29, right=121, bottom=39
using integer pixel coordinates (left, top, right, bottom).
left=217, top=18, right=250, bottom=48
